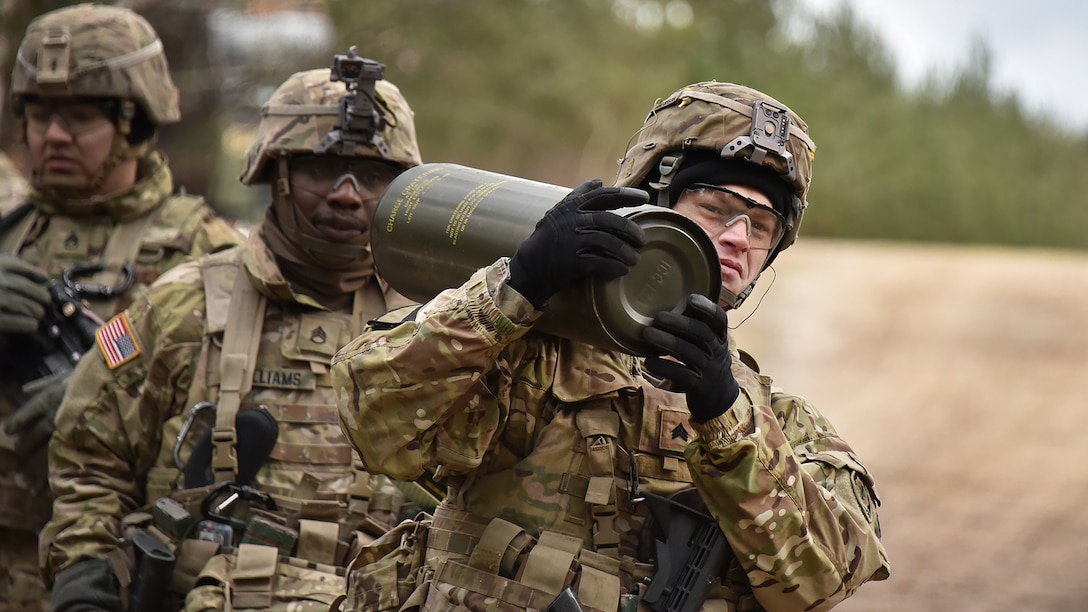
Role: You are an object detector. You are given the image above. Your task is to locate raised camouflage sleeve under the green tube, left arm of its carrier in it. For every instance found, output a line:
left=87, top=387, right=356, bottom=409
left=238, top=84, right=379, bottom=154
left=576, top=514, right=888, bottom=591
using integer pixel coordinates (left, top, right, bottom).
left=332, top=259, right=536, bottom=480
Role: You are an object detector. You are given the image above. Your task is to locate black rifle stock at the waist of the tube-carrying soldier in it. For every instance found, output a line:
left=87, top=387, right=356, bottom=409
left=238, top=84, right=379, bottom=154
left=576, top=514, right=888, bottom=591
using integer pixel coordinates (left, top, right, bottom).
left=642, top=493, right=729, bottom=612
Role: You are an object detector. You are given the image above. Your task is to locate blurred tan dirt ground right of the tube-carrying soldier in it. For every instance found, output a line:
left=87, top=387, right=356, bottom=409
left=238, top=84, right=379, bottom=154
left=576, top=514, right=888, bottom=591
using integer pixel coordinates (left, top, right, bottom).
left=730, top=238, right=1088, bottom=612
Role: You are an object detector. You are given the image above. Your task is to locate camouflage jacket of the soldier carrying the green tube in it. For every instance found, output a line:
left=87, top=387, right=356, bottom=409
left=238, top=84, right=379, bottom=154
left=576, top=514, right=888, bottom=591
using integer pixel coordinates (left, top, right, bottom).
left=333, top=259, right=889, bottom=611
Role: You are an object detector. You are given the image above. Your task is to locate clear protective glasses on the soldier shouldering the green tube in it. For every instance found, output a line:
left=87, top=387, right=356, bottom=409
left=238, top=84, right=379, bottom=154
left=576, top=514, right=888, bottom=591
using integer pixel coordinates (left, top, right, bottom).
left=677, top=183, right=786, bottom=249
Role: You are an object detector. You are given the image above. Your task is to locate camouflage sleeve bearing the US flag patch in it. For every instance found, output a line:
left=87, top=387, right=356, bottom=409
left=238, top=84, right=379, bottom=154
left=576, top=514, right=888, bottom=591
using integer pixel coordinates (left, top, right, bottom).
left=39, top=265, right=203, bottom=582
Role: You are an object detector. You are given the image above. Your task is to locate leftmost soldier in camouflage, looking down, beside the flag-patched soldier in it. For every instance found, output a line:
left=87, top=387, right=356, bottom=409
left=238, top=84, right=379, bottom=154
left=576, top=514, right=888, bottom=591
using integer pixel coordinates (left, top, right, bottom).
left=0, top=4, right=242, bottom=610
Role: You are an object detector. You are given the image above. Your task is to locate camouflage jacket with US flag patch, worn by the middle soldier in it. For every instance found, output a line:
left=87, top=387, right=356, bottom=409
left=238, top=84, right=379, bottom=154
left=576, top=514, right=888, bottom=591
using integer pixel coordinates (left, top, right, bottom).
left=40, top=229, right=406, bottom=609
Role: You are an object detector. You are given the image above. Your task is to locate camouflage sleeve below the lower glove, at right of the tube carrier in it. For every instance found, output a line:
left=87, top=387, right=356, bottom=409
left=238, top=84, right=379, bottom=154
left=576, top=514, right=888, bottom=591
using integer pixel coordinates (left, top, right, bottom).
left=685, top=391, right=889, bottom=610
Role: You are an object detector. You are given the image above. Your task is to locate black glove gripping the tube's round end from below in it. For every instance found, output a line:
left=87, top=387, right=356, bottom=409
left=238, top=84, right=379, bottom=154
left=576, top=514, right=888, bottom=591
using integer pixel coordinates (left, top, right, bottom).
left=642, top=293, right=741, bottom=423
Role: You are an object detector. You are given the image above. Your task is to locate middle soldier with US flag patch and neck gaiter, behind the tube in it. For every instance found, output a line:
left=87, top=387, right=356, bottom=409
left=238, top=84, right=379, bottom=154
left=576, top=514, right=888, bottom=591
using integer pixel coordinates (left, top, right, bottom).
left=41, top=59, right=421, bottom=610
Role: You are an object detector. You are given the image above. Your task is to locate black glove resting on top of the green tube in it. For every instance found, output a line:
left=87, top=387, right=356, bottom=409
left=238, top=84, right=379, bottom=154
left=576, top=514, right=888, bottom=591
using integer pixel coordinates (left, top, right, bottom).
left=509, top=179, right=650, bottom=309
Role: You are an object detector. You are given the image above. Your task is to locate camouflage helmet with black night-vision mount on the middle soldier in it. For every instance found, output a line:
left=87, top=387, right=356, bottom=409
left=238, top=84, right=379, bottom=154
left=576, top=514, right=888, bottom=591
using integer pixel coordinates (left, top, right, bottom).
left=240, top=69, right=422, bottom=185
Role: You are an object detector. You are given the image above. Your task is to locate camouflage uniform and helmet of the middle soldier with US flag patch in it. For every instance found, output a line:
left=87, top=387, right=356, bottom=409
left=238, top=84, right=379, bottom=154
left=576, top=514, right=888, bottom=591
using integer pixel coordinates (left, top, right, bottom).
left=41, top=70, right=420, bottom=610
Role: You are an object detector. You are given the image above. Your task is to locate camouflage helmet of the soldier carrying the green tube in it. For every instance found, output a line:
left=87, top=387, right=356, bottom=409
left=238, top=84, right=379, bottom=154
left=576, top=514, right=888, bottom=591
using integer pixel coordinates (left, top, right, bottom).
left=616, top=81, right=816, bottom=267
